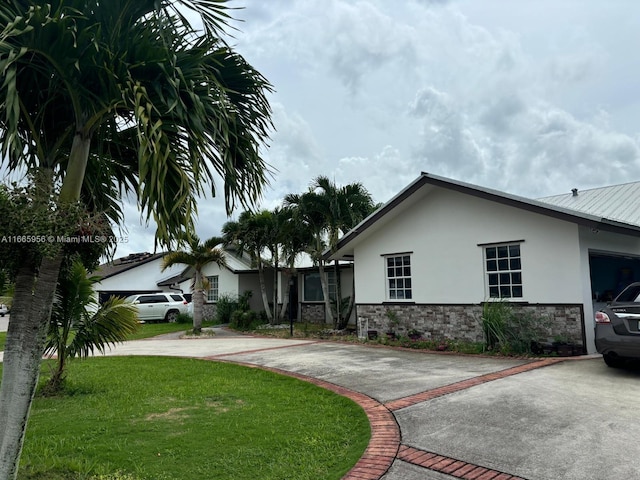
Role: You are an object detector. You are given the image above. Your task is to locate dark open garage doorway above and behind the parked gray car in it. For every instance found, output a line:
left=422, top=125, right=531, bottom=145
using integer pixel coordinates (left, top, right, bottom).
left=589, top=252, right=640, bottom=309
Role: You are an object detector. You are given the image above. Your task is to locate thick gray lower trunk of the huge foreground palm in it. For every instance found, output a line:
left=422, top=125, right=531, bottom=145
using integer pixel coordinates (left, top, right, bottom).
left=0, top=256, right=62, bottom=480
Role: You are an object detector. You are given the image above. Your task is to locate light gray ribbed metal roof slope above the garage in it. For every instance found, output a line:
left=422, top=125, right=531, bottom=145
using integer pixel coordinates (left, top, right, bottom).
left=538, top=182, right=640, bottom=230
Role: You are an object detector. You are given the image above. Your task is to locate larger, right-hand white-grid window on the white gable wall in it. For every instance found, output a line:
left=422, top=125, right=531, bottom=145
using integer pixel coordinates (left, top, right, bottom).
left=484, top=244, right=522, bottom=298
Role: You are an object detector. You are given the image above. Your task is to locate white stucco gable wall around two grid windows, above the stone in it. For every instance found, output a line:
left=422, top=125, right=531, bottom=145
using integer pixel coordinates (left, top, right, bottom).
left=354, top=188, right=583, bottom=304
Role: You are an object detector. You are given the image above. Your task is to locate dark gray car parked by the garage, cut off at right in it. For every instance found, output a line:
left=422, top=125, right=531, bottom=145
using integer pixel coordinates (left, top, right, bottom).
left=596, top=282, right=640, bottom=367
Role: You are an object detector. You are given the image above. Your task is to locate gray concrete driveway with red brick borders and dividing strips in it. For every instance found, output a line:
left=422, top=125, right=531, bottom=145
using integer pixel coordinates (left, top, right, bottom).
left=2, top=330, right=640, bottom=480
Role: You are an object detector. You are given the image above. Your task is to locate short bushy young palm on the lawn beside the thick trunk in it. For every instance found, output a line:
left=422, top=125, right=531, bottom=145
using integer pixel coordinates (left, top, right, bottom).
left=45, top=259, right=138, bottom=392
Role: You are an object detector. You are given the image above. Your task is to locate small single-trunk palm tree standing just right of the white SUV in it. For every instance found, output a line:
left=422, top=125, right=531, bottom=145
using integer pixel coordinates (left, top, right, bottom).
left=162, top=235, right=227, bottom=333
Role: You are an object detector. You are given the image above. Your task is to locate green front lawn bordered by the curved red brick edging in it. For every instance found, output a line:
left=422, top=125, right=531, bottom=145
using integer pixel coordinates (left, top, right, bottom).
left=7, top=357, right=370, bottom=480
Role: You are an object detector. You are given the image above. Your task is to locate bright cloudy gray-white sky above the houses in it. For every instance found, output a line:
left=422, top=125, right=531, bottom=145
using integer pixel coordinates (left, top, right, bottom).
left=117, top=0, right=640, bottom=256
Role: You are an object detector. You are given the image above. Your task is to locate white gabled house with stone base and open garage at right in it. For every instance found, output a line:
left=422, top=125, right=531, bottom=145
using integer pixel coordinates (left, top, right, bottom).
left=326, top=173, right=640, bottom=352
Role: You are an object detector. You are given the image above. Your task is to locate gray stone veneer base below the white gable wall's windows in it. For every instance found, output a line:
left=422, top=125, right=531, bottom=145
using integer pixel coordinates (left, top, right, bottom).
left=356, top=303, right=585, bottom=345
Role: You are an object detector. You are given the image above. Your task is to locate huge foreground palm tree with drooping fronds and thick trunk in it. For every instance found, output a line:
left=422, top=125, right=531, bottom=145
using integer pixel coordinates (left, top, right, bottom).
left=0, top=0, right=271, bottom=480
